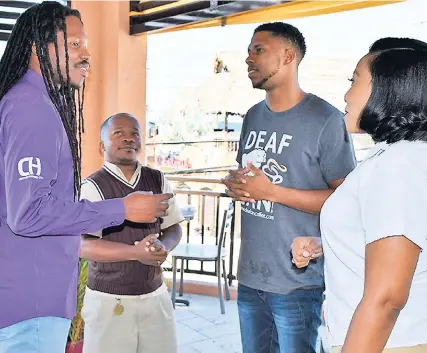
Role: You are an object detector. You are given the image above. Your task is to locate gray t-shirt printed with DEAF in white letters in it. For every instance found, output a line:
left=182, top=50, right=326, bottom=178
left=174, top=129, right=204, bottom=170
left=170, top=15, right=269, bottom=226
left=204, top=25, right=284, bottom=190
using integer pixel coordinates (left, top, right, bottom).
left=237, top=94, right=356, bottom=294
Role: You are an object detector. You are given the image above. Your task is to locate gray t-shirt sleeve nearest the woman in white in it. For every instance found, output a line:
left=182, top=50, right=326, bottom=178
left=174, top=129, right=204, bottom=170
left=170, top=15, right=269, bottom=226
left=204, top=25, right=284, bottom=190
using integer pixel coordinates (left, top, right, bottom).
left=318, top=111, right=356, bottom=182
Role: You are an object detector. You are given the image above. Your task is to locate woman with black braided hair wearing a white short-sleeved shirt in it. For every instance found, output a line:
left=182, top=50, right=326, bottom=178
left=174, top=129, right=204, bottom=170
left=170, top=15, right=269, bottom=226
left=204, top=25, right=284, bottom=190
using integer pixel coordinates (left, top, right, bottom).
left=321, top=45, right=427, bottom=353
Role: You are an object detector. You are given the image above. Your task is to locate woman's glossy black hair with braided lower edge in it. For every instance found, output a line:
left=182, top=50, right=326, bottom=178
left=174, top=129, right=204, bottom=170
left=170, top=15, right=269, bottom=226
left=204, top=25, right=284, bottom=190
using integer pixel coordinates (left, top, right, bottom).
left=359, top=49, right=427, bottom=143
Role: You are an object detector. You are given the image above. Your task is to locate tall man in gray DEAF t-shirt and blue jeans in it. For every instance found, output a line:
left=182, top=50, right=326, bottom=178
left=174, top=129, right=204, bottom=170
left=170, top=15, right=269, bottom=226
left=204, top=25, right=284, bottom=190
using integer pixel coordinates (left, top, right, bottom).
left=224, top=23, right=355, bottom=353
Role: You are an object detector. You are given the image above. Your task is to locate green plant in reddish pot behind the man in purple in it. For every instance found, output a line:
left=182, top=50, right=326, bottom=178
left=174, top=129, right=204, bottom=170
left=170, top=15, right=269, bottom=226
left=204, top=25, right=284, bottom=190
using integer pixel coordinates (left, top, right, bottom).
left=65, top=259, right=88, bottom=353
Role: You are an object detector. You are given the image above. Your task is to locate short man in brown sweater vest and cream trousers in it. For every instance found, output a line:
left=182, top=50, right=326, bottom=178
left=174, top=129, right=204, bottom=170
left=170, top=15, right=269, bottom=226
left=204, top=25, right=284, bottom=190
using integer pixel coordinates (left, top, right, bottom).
left=80, top=113, right=184, bottom=353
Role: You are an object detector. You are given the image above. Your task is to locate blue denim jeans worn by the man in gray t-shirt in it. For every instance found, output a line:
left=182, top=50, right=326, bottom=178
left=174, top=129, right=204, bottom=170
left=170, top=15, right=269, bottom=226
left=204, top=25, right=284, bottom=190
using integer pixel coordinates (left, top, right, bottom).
left=237, top=284, right=323, bottom=353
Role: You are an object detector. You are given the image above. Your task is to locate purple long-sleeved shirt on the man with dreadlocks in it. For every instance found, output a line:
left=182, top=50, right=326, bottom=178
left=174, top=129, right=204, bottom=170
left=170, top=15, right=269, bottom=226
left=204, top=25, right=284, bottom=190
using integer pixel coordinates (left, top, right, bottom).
left=0, top=70, right=125, bottom=328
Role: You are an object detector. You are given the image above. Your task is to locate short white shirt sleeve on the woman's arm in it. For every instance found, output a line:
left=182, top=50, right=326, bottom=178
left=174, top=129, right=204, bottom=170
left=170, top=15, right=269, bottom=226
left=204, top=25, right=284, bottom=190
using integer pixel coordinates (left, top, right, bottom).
left=359, top=155, right=427, bottom=249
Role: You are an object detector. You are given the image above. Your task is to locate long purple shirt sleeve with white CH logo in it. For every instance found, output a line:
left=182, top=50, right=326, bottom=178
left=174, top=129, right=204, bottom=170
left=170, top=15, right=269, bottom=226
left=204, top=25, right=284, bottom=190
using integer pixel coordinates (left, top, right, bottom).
left=0, top=98, right=125, bottom=237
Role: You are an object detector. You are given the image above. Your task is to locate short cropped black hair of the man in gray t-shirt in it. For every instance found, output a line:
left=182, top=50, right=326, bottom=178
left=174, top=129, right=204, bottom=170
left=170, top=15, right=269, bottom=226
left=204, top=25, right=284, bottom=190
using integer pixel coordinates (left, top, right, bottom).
left=254, top=22, right=307, bottom=61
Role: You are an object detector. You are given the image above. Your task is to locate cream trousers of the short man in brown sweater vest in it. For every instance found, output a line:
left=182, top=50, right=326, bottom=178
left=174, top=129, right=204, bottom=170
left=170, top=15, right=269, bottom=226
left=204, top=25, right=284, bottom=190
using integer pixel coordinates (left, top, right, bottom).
left=82, top=285, right=178, bottom=353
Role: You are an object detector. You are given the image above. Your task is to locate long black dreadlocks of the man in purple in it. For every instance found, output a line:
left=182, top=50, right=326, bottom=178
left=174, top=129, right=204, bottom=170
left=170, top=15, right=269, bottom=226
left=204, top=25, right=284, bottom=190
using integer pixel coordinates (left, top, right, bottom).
left=0, top=1, right=85, bottom=197
